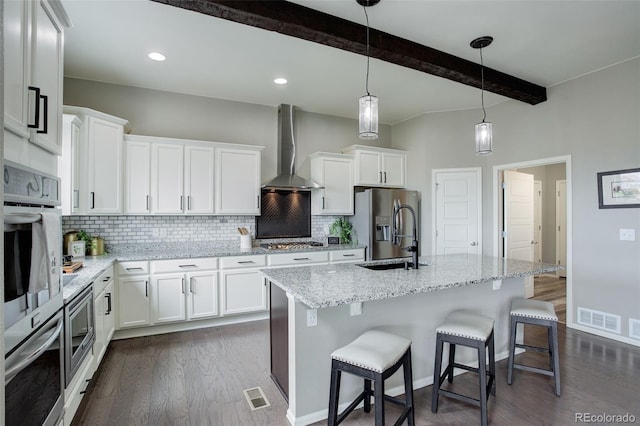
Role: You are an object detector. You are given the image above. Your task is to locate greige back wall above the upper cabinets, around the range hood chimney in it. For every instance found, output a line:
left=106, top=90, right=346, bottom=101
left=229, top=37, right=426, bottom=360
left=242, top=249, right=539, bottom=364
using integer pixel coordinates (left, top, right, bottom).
left=63, top=78, right=391, bottom=181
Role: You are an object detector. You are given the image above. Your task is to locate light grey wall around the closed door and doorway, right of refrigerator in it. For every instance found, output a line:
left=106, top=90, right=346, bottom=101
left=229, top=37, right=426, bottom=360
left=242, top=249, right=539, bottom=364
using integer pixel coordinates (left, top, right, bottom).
left=391, top=59, right=640, bottom=342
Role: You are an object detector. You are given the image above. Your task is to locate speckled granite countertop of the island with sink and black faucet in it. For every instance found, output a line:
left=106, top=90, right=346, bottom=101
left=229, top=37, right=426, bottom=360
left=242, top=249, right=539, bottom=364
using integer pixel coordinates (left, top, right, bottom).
left=262, top=254, right=559, bottom=309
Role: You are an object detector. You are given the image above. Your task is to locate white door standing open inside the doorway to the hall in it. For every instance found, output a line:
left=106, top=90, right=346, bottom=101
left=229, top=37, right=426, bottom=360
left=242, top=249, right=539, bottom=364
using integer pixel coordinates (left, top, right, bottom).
left=503, top=170, right=534, bottom=297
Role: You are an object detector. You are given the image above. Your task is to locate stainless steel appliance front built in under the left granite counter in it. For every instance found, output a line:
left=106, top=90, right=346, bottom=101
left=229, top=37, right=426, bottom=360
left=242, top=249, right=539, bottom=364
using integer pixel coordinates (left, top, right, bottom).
left=64, top=285, right=96, bottom=386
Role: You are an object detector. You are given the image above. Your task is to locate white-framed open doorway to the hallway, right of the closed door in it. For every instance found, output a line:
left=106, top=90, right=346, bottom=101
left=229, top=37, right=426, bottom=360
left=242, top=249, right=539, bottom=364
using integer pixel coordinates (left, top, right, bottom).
left=493, top=156, right=572, bottom=323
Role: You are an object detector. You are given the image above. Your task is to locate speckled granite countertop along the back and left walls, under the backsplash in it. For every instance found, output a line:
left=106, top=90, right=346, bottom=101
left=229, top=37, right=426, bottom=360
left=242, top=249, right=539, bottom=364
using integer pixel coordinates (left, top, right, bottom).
left=63, top=241, right=364, bottom=303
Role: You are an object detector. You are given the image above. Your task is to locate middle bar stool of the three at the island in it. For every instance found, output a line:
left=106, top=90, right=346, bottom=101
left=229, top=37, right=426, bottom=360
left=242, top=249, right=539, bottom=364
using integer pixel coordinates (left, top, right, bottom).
left=431, top=311, right=496, bottom=426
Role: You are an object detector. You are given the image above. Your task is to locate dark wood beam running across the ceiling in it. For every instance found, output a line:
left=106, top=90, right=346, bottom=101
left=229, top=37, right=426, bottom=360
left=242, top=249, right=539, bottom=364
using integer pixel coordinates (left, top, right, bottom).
left=153, top=0, right=547, bottom=105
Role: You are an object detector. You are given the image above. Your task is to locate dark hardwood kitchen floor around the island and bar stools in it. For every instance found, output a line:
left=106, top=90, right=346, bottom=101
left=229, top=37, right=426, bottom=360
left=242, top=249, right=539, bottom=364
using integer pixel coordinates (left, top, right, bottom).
left=74, top=321, right=640, bottom=426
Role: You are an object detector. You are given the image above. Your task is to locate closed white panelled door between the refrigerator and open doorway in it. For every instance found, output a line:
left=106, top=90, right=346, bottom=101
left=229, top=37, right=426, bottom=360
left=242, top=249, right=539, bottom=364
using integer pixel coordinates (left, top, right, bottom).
left=434, top=169, right=482, bottom=255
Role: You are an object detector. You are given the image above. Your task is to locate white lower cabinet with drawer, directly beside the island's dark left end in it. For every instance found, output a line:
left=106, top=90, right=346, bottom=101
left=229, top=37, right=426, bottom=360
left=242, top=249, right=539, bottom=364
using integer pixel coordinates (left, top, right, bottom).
left=220, top=255, right=268, bottom=315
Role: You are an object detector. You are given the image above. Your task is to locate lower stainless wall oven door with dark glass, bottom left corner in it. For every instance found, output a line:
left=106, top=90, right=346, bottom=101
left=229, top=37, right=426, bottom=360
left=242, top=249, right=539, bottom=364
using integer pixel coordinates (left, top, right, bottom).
left=4, top=311, right=64, bottom=426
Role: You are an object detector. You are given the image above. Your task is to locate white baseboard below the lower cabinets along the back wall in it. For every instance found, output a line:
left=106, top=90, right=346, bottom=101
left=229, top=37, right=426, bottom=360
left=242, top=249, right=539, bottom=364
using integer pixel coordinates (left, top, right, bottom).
left=112, top=311, right=269, bottom=340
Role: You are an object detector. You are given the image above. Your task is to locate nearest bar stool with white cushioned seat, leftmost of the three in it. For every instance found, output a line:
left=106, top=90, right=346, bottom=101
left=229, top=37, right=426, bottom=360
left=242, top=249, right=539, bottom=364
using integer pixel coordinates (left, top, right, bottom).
left=328, top=330, right=414, bottom=426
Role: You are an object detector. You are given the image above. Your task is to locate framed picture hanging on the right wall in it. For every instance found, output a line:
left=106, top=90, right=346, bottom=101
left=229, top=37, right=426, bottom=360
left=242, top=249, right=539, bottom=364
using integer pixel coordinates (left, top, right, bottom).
left=598, top=169, right=640, bottom=209
